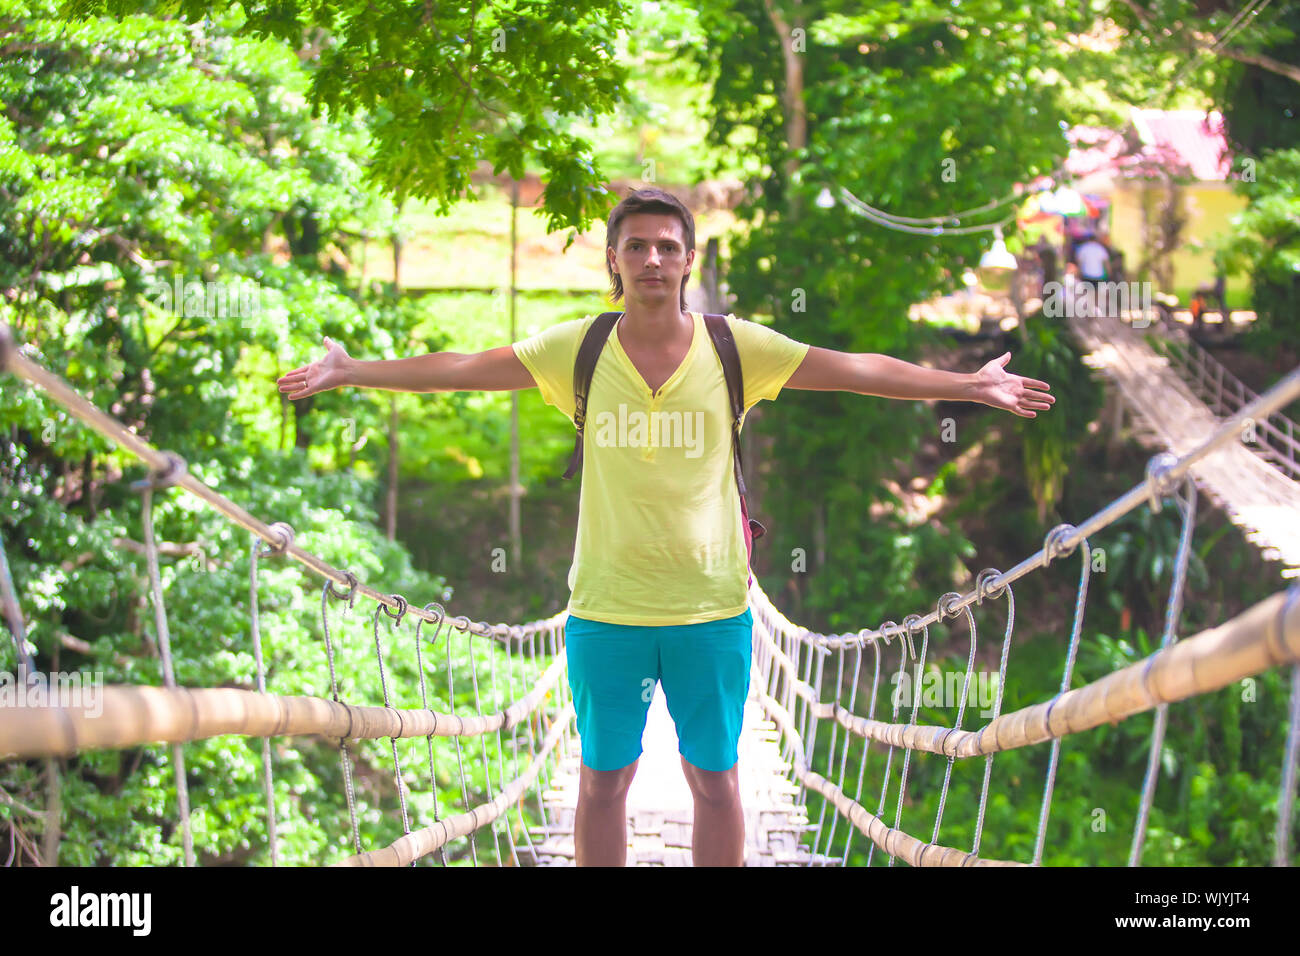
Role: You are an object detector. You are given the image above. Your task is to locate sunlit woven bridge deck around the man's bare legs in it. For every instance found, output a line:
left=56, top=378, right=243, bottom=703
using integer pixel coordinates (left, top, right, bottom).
left=520, top=674, right=837, bottom=866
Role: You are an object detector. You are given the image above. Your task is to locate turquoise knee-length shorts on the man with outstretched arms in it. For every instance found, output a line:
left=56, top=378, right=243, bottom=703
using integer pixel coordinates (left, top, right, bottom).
left=564, top=607, right=754, bottom=770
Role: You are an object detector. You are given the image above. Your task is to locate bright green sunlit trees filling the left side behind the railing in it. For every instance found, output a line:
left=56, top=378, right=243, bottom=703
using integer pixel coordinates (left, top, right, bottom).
left=0, top=3, right=543, bottom=865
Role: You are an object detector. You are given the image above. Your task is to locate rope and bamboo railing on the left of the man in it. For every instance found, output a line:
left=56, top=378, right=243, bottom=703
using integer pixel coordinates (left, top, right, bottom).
left=0, top=324, right=572, bottom=865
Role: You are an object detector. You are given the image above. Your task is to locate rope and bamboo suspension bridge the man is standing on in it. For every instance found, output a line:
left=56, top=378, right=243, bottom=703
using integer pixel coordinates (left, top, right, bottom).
left=0, top=326, right=1300, bottom=866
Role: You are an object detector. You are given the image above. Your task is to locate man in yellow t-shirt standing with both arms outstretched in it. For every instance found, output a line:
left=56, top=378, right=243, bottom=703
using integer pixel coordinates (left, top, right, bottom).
left=280, top=189, right=1056, bottom=866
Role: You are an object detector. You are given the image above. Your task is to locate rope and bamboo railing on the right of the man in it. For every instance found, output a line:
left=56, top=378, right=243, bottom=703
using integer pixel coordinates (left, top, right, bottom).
left=750, top=353, right=1300, bottom=865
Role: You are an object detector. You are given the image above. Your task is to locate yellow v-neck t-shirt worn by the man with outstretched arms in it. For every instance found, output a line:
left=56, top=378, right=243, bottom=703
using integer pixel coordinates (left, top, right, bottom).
left=514, top=312, right=809, bottom=626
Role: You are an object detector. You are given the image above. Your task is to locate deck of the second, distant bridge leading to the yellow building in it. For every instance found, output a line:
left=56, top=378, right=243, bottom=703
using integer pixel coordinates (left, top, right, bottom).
left=1071, top=310, right=1300, bottom=578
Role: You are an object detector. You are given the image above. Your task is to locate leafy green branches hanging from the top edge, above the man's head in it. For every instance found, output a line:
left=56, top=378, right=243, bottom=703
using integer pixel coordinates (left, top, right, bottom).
left=62, top=0, right=639, bottom=239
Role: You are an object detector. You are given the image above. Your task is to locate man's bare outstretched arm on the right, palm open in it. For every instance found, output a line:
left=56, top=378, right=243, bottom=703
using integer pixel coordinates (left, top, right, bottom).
left=785, top=346, right=1056, bottom=419
